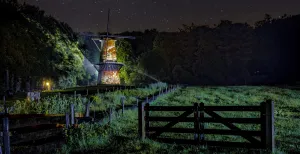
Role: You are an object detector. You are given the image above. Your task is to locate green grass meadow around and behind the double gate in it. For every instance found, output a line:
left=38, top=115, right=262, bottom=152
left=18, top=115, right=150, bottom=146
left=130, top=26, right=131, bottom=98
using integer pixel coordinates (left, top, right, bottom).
left=59, top=86, right=300, bottom=153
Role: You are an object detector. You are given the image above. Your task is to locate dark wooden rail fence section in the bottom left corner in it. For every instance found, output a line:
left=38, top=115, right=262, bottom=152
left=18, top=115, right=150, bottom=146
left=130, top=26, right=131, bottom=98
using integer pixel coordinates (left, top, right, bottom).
left=0, top=103, right=93, bottom=154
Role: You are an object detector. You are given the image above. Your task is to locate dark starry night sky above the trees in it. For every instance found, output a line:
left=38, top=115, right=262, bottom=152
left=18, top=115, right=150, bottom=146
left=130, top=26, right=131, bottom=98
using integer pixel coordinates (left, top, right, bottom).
left=22, top=0, right=300, bottom=33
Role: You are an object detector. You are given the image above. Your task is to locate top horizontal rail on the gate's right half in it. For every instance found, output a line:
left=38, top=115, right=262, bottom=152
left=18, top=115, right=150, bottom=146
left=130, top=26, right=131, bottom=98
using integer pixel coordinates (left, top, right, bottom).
left=204, top=106, right=260, bottom=112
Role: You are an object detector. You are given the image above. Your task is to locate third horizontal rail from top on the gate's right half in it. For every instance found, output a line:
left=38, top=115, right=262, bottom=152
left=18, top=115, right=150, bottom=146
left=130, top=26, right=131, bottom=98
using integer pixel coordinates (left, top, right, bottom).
left=204, top=129, right=261, bottom=136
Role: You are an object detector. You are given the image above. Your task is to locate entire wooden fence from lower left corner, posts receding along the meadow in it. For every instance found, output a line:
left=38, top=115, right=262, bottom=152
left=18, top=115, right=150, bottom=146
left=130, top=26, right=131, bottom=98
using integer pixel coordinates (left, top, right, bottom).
left=0, top=86, right=177, bottom=154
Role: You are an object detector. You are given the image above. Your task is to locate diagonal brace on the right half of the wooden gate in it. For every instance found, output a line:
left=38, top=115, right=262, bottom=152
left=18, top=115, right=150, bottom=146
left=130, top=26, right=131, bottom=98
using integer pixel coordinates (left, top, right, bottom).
left=206, top=111, right=260, bottom=145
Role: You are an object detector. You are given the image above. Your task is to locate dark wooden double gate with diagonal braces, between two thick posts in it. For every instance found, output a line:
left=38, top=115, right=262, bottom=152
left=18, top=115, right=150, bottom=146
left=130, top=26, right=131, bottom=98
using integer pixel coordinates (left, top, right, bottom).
left=138, top=100, right=275, bottom=151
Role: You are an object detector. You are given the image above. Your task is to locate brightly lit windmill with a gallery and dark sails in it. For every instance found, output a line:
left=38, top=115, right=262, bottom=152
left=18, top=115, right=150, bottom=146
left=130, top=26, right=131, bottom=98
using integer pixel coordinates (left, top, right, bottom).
left=92, top=10, right=135, bottom=84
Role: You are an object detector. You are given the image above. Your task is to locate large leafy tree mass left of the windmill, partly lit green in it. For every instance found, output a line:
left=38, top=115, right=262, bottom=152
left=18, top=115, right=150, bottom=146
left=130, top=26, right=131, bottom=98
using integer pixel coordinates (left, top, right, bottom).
left=0, top=2, right=84, bottom=88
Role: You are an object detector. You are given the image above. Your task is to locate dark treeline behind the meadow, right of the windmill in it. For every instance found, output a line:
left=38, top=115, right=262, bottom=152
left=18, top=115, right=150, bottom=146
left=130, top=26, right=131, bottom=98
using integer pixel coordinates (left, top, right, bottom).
left=85, top=14, right=300, bottom=85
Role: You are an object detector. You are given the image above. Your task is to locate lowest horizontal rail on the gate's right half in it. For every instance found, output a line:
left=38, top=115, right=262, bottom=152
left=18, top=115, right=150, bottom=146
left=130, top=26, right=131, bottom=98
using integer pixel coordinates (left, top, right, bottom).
left=204, top=141, right=261, bottom=149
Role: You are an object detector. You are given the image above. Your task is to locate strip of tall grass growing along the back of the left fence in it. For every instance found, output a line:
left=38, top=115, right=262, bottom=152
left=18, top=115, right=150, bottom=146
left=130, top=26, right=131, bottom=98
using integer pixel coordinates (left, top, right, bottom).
left=2, top=83, right=167, bottom=114
